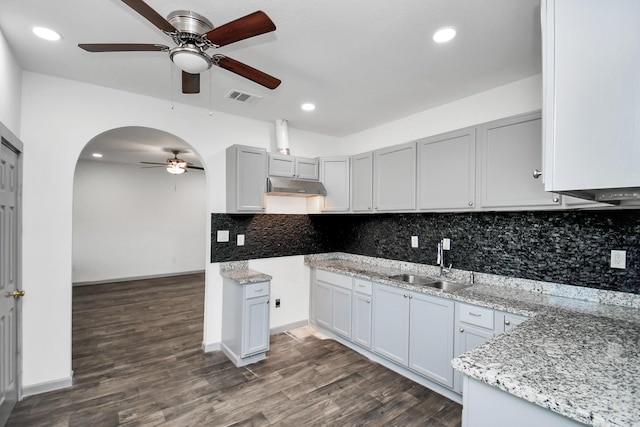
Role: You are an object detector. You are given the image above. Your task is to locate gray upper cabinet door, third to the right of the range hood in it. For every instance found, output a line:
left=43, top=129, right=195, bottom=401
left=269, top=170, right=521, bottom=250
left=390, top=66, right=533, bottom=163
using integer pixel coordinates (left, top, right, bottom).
left=373, top=142, right=416, bottom=211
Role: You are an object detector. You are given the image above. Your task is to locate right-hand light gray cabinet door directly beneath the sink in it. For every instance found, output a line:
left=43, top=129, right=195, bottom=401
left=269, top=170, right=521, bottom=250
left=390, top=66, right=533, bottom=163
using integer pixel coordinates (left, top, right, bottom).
left=409, top=293, right=455, bottom=387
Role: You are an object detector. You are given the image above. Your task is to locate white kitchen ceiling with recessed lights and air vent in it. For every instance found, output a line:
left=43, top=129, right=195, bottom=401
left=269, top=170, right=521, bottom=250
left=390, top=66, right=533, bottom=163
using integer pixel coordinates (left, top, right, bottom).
left=0, top=0, right=541, bottom=136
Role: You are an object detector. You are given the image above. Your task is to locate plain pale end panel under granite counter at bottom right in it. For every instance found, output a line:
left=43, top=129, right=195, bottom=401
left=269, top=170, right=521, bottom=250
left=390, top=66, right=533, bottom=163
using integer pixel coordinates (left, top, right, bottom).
left=462, top=376, right=584, bottom=427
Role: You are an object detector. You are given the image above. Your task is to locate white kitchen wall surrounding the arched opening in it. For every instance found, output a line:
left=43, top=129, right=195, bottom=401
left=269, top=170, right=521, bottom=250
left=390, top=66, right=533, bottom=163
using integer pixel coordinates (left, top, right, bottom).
left=21, top=72, right=337, bottom=389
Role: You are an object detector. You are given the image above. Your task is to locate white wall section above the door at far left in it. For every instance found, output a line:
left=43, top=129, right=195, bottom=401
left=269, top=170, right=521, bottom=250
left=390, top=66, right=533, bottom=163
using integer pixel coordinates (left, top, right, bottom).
left=0, top=30, right=22, bottom=137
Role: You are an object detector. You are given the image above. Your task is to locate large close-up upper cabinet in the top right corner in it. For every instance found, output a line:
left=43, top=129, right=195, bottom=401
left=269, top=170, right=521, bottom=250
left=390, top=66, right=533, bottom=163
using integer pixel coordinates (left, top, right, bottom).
left=542, top=0, right=640, bottom=194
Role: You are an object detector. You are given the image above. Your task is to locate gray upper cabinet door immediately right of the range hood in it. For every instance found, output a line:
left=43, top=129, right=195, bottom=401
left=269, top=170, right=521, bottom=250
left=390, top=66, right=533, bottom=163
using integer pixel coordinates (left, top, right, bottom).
left=320, top=157, right=350, bottom=212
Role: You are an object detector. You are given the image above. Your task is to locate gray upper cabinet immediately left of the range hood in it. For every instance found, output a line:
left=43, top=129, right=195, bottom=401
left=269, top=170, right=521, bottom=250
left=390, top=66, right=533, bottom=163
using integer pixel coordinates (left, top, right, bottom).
left=226, top=145, right=267, bottom=213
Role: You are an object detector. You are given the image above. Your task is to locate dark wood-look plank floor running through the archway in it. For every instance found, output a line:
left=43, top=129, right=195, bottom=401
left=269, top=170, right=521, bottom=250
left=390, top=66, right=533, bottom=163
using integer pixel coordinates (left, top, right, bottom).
left=8, top=275, right=462, bottom=427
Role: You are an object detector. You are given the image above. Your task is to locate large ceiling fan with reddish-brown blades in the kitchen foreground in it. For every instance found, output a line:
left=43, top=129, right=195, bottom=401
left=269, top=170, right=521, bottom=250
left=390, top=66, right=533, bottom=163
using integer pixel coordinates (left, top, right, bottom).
left=78, top=0, right=281, bottom=94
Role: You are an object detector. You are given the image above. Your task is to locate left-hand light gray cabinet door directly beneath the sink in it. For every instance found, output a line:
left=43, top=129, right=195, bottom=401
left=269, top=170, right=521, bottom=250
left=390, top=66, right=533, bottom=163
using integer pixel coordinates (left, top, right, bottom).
left=373, top=284, right=409, bottom=366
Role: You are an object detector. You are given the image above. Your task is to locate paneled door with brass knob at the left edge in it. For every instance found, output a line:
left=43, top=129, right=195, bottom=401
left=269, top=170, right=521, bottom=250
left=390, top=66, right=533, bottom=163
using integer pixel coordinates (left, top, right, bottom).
left=0, top=142, right=18, bottom=425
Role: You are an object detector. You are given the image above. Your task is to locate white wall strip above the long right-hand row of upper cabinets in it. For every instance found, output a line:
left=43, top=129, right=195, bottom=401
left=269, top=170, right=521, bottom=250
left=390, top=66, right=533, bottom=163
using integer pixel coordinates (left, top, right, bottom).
left=339, top=74, right=542, bottom=155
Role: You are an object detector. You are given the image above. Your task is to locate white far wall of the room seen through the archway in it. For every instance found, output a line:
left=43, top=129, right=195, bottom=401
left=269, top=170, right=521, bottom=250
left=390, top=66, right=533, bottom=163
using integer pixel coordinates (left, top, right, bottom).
left=72, top=160, right=210, bottom=283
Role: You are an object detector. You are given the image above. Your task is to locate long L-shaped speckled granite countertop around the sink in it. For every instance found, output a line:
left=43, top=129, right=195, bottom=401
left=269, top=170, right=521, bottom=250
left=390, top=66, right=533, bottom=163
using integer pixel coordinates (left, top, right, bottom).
left=305, top=257, right=640, bottom=426
